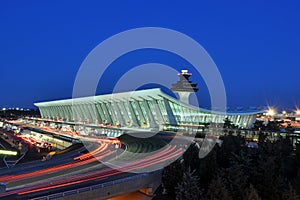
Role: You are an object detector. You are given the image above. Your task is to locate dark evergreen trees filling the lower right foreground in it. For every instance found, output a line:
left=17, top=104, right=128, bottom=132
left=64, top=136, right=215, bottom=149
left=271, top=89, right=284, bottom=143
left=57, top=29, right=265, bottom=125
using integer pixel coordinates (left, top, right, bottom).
left=162, top=133, right=300, bottom=200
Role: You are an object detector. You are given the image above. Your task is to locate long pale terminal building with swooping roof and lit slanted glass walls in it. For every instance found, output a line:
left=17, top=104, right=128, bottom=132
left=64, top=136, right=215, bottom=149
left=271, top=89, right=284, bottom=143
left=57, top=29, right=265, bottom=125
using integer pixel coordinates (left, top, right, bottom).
left=35, top=88, right=262, bottom=129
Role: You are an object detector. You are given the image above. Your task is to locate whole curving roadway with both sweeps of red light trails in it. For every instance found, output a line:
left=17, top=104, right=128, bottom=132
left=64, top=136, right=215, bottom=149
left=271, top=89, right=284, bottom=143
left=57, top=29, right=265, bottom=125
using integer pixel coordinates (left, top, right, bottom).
left=0, top=129, right=184, bottom=199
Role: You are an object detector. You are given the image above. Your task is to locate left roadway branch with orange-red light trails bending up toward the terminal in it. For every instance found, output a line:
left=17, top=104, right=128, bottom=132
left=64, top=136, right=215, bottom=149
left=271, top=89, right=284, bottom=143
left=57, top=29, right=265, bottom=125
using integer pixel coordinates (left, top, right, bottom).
left=0, top=140, right=113, bottom=197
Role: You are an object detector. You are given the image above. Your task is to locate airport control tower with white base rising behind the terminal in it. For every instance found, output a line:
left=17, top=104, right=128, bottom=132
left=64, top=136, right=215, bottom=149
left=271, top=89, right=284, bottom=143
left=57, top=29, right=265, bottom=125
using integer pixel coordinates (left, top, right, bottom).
left=171, top=70, right=198, bottom=104
